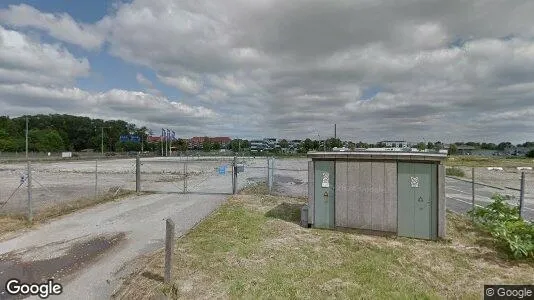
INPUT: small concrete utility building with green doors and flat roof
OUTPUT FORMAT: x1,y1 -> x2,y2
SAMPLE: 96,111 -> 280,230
308,151 -> 446,240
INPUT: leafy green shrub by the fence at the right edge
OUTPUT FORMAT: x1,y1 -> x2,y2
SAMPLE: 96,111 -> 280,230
469,194 -> 534,259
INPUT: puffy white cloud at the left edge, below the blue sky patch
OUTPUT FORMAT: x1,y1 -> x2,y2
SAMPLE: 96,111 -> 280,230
0,26 -> 90,85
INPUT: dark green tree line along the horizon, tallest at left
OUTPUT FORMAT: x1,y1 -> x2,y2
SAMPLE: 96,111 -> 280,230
0,114 -> 534,153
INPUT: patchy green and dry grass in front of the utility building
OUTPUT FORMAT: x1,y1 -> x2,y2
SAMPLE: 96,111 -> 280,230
117,186 -> 534,299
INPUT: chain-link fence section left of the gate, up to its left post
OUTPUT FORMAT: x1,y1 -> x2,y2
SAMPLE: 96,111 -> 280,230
0,159 -> 135,216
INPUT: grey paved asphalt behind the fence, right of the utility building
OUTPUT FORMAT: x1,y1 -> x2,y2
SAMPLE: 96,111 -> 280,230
445,178 -> 534,221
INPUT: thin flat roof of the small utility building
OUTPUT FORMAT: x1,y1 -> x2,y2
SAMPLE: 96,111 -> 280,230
308,151 -> 447,161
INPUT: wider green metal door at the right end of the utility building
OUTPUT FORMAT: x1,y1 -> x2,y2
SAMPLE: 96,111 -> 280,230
397,162 -> 437,239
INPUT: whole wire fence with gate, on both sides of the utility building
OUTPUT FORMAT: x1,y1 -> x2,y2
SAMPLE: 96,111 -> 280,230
0,156 -> 534,221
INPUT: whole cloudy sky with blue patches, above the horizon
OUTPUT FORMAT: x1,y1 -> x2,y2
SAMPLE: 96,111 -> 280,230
0,0 -> 534,143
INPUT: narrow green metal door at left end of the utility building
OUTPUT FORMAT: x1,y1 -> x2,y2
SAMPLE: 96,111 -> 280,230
313,161 -> 336,228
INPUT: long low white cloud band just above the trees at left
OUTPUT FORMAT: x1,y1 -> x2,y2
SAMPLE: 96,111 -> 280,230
0,84 -> 218,127
